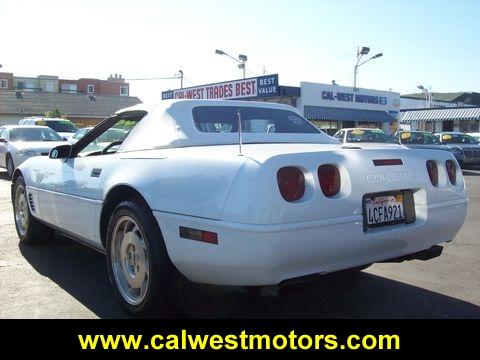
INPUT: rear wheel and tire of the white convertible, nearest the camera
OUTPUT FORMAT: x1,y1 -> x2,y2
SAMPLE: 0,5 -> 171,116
106,199 -> 181,317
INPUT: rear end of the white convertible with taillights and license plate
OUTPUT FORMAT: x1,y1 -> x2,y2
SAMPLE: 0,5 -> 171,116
159,144 -> 467,286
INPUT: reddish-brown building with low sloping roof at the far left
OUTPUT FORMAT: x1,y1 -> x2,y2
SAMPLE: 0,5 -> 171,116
0,72 -> 141,126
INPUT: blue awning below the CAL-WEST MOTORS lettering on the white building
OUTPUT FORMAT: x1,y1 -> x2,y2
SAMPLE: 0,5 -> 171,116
304,106 -> 396,123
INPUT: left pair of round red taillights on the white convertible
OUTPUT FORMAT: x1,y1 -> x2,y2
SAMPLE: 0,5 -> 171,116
277,165 -> 341,202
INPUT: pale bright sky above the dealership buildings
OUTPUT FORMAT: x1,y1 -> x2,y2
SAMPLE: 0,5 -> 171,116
0,0 -> 480,102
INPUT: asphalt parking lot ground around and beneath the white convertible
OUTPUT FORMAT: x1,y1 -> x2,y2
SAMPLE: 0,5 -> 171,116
0,168 -> 480,318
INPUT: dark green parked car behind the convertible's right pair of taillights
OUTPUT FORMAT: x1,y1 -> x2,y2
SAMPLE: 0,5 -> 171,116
394,131 -> 464,165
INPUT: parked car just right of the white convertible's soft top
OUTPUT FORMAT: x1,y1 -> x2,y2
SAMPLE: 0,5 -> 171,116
333,128 -> 404,149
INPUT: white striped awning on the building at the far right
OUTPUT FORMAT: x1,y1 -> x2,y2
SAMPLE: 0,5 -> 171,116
400,107 -> 480,122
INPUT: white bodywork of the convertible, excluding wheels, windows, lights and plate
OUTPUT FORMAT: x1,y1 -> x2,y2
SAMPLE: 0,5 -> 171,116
15,101 -> 467,286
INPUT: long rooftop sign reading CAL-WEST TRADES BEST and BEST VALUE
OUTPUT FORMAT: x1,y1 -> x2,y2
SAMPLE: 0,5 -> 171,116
162,74 -> 278,100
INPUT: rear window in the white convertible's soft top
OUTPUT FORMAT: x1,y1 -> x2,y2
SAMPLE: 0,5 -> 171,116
193,106 -> 320,134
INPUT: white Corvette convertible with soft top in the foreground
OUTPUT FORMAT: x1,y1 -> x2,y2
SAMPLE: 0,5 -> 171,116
12,100 -> 467,314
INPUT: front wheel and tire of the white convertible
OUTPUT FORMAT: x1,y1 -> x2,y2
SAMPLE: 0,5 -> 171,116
12,175 -> 55,245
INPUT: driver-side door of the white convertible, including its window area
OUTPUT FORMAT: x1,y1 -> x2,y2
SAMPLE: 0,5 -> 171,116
42,112 -> 145,247
